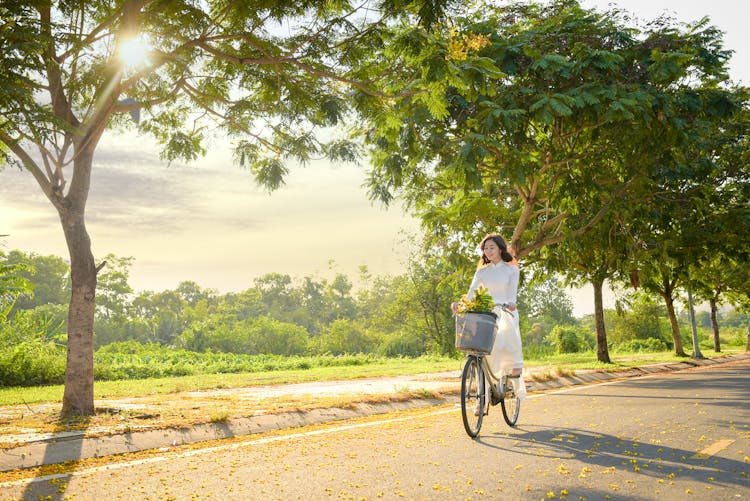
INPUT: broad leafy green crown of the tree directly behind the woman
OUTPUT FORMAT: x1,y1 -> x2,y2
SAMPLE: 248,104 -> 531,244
368,0 -> 741,356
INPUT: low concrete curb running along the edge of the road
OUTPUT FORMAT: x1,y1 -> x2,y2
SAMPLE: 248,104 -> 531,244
0,353 -> 750,472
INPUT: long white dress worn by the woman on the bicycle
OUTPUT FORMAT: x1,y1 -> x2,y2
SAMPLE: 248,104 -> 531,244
466,261 -> 526,399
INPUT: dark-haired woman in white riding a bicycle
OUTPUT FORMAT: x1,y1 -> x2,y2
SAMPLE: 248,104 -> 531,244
451,234 -> 526,399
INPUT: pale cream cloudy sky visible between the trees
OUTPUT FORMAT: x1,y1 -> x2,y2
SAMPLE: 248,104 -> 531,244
0,0 -> 750,316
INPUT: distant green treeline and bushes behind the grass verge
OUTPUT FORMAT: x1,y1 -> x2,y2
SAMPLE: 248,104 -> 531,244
0,250 -> 750,386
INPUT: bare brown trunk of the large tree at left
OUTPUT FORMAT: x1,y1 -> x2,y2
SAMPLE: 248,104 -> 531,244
58,151 -> 98,417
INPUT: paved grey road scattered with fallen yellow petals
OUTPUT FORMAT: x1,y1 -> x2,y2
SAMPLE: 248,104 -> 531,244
0,361 -> 750,501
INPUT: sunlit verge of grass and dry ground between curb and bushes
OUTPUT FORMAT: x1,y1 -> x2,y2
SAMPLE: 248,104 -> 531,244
0,349 -> 744,442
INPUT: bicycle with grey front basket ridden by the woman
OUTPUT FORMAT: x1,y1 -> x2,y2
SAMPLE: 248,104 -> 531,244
456,304 -> 521,438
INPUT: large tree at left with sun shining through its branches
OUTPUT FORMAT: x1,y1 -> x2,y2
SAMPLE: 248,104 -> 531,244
0,0 -> 446,415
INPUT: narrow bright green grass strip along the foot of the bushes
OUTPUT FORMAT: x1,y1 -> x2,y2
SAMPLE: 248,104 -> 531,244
0,348 -> 744,406
